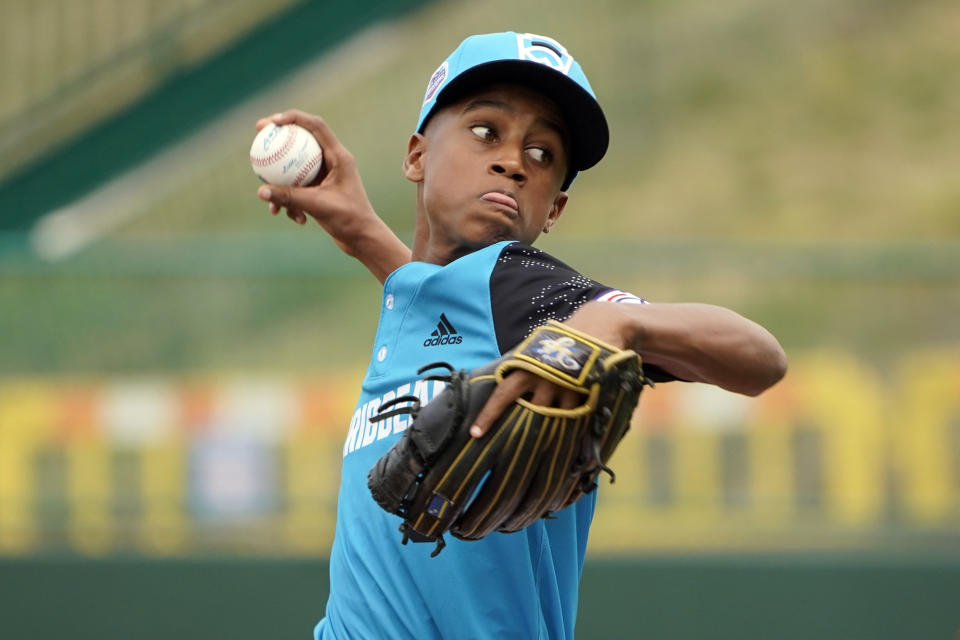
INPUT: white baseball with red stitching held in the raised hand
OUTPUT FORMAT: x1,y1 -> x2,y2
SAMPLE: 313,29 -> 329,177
250,123 -> 323,187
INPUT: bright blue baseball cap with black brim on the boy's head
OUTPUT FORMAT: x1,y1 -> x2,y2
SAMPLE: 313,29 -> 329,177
417,31 -> 610,190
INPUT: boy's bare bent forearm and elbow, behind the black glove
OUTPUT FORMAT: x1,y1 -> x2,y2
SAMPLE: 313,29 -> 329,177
568,303 -> 787,395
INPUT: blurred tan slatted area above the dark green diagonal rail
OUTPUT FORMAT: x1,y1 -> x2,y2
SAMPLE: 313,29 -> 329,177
0,0 -> 296,175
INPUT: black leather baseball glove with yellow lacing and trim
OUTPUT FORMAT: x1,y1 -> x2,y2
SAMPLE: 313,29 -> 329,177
368,322 -> 647,555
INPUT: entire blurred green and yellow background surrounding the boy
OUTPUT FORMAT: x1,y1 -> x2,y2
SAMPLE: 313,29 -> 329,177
0,0 -> 960,638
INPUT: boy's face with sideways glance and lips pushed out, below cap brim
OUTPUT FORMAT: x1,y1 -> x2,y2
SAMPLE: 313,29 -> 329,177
404,85 -> 569,258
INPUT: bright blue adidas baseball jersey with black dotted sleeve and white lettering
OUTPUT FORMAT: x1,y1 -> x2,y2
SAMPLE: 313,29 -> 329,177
315,242 -> 670,640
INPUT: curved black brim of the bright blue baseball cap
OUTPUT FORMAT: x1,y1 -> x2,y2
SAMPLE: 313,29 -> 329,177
420,60 -> 610,182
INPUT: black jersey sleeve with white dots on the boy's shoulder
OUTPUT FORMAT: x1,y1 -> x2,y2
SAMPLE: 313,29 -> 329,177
490,243 -> 679,382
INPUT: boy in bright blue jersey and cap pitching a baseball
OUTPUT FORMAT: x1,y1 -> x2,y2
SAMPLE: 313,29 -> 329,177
258,32 -> 786,640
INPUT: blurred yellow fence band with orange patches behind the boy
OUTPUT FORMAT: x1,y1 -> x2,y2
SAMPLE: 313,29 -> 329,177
0,344 -> 960,554
